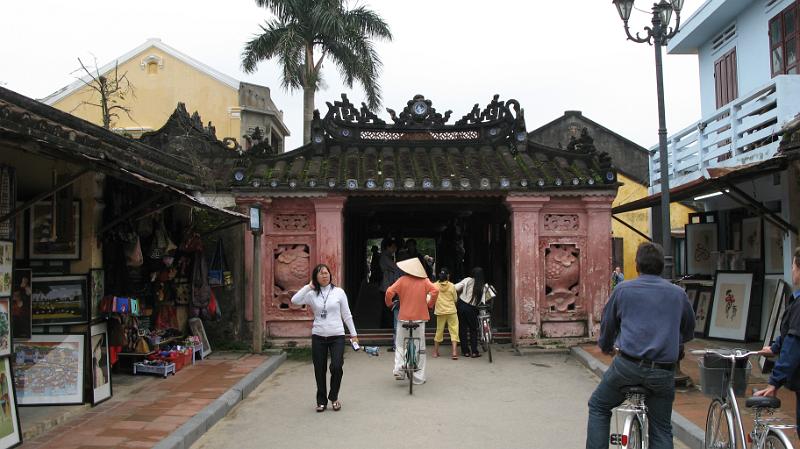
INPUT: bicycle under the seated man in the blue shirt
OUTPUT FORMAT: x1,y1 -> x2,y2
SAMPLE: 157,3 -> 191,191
609,385 -> 650,449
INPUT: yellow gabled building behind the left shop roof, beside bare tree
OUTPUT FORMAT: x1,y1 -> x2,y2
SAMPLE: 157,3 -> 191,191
41,39 -> 289,152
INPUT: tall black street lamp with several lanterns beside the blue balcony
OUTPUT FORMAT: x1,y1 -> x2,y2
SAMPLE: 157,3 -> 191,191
613,0 -> 683,279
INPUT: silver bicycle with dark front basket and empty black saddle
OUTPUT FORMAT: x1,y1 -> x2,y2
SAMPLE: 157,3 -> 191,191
692,349 -> 797,449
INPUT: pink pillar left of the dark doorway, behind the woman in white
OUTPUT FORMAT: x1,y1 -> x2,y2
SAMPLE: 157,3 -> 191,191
312,196 -> 347,285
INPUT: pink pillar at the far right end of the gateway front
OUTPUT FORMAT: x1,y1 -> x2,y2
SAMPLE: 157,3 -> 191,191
581,196 -> 616,338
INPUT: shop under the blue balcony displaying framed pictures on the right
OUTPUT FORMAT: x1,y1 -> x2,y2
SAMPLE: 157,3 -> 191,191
612,130 -> 800,344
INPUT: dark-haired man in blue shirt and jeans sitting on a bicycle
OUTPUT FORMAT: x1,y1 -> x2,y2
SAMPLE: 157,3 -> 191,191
586,242 -> 694,449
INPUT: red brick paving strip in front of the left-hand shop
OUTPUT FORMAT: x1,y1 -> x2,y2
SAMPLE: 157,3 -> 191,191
19,354 -> 267,449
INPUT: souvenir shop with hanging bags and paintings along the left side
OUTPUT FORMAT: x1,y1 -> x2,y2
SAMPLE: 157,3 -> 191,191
0,88 -> 246,448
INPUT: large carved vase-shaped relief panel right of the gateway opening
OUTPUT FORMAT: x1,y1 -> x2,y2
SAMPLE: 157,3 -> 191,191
544,244 -> 581,313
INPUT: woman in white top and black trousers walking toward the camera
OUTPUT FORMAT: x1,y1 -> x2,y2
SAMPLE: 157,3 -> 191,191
292,264 -> 358,412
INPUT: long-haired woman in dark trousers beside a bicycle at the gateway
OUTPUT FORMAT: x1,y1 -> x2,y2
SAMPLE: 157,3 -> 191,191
455,267 -> 488,357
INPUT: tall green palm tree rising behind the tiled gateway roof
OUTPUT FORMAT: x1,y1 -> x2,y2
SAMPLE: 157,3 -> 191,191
242,0 -> 392,144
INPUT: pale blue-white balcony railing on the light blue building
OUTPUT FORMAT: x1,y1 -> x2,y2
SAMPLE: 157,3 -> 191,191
649,75 -> 800,194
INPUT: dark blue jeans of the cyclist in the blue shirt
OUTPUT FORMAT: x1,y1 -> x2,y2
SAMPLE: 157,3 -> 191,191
586,357 -> 675,449
